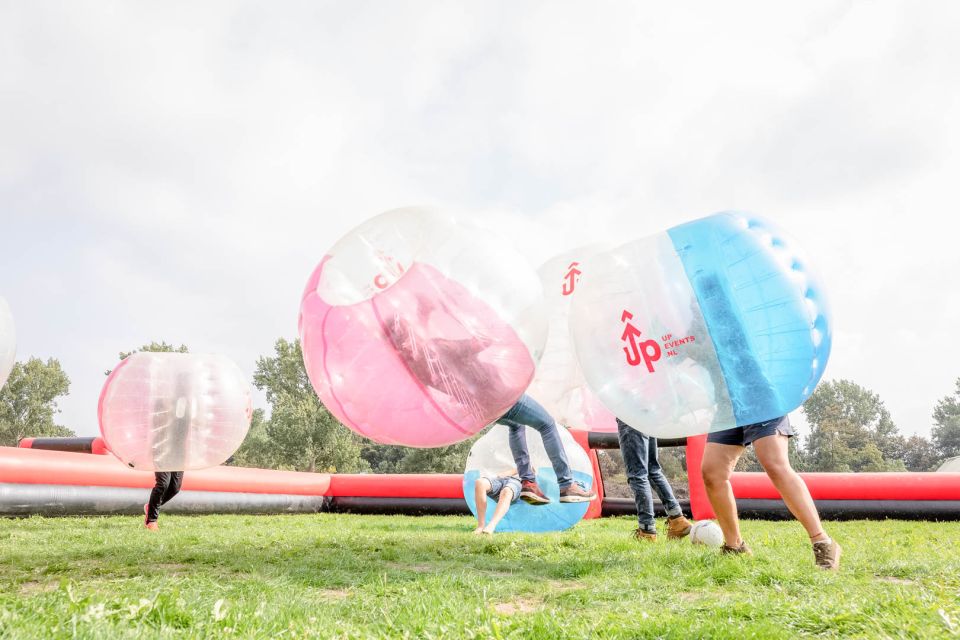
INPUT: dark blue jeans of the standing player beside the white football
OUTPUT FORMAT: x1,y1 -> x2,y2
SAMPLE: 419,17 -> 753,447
617,418 -> 683,532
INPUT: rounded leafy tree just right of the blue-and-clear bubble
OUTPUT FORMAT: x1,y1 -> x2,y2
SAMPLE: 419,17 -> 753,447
803,380 -> 905,471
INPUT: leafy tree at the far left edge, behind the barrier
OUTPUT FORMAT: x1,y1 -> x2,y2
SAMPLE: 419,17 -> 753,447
0,358 -> 76,447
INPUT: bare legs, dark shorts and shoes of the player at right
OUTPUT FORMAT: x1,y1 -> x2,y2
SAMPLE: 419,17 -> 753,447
701,416 -> 841,569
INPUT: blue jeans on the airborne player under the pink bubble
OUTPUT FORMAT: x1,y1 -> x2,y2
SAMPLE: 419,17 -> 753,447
497,394 -> 573,489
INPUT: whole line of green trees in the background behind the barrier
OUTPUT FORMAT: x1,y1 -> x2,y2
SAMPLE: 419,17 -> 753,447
0,338 -> 960,473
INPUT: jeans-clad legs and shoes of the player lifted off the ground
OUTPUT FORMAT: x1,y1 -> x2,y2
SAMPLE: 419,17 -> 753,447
497,394 -> 597,505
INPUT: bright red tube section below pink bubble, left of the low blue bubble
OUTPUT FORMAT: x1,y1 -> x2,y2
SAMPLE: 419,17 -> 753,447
327,473 -> 463,500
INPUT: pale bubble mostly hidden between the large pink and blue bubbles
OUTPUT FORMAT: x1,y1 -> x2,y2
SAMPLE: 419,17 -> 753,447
527,245 -> 617,433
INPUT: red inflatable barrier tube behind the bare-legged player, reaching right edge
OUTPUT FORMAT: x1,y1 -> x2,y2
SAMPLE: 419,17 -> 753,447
730,472 -> 960,500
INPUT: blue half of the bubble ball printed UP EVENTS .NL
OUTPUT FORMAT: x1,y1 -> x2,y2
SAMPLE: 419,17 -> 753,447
667,212 -> 831,425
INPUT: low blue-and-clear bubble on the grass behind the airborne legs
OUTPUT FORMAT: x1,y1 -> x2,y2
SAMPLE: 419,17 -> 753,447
463,424 -> 593,532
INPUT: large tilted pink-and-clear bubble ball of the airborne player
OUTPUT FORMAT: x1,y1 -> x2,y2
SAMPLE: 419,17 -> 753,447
300,208 -> 546,447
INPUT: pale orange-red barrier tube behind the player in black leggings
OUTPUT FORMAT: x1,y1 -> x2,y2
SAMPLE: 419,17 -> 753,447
0,447 -> 330,496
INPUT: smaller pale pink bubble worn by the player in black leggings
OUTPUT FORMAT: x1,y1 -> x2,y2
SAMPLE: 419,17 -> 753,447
99,352 -> 251,471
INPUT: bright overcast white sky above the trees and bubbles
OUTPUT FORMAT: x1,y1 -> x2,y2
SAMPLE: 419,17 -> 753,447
0,0 -> 960,435
